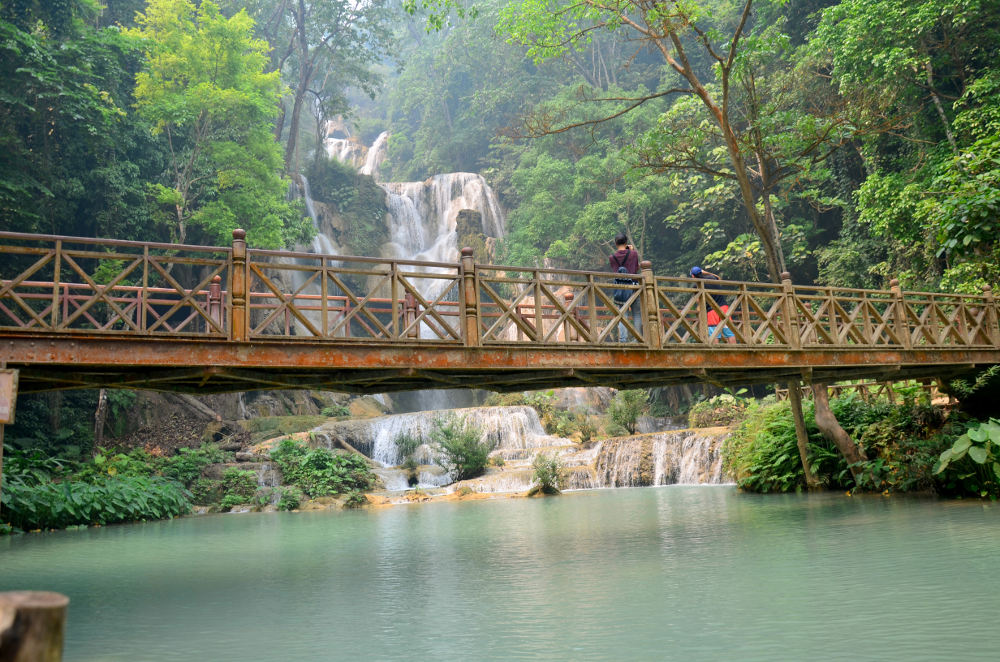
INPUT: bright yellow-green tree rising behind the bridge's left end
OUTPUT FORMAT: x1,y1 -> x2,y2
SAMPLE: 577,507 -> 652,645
129,0 -> 308,247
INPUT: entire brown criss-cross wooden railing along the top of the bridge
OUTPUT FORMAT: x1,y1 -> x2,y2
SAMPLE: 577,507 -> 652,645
0,231 -> 1000,350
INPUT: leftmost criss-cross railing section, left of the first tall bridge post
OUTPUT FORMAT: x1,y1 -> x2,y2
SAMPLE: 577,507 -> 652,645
0,232 -> 231,338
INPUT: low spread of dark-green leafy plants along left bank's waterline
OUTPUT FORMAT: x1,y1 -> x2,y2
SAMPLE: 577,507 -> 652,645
2,476 -> 191,530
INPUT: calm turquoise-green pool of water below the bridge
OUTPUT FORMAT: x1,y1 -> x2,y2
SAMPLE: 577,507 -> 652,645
0,487 -> 1000,662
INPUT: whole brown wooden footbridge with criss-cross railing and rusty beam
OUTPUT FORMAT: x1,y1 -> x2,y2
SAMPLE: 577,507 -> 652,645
0,230 -> 1000,393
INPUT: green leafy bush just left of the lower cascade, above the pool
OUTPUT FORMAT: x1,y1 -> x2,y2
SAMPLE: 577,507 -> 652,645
271,439 -> 375,498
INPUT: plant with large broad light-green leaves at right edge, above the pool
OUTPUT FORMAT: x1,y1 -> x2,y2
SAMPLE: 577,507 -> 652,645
934,418 -> 1000,499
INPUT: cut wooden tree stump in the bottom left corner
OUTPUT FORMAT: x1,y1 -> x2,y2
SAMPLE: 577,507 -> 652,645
0,591 -> 69,662
